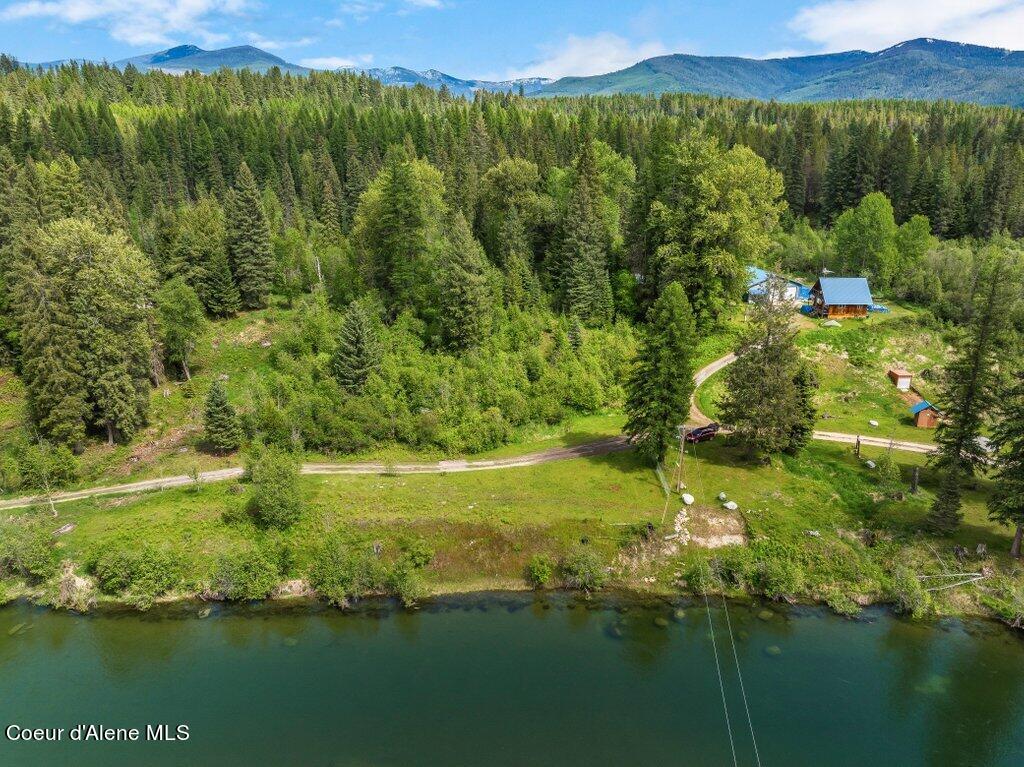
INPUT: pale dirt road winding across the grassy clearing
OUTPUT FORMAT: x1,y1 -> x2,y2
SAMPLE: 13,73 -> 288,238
0,353 -> 935,511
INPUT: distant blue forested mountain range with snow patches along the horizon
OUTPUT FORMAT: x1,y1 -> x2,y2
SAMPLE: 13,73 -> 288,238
22,38 -> 1024,106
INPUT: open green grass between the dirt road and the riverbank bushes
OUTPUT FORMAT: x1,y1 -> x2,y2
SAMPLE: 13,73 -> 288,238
14,441 -> 1010,606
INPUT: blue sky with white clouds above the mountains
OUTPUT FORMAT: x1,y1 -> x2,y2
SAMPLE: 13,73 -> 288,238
6,0 -> 1024,79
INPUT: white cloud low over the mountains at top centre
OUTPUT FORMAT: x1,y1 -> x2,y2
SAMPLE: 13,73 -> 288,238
503,32 -> 669,80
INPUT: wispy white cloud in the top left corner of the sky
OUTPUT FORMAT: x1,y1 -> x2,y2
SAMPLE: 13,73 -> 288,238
0,0 -> 249,45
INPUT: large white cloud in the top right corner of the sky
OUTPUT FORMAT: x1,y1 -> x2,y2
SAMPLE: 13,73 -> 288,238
788,0 -> 1024,51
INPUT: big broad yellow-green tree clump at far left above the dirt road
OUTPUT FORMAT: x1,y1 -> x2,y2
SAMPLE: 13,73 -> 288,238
15,218 -> 154,445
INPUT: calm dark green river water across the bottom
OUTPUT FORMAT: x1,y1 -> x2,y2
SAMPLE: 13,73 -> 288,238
0,596 -> 1024,767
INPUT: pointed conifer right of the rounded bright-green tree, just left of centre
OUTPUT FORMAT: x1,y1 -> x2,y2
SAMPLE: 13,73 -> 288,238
439,211 -> 492,350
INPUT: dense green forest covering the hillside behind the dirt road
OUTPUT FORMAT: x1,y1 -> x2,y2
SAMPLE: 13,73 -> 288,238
0,58 -> 1024,489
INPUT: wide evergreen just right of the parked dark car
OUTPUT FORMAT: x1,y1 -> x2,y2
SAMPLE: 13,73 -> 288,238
721,279 -> 815,458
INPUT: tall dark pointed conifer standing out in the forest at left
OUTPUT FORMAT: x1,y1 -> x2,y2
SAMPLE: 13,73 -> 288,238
227,162 -> 274,309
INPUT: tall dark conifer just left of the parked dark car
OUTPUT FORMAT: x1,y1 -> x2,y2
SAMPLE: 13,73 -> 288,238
626,283 -> 696,462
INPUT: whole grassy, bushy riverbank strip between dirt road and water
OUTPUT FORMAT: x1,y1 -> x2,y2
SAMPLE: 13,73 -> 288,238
0,445 -> 1024,628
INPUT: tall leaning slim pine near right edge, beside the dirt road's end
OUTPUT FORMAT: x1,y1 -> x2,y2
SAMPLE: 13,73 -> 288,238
927,246 -> 1015,534
